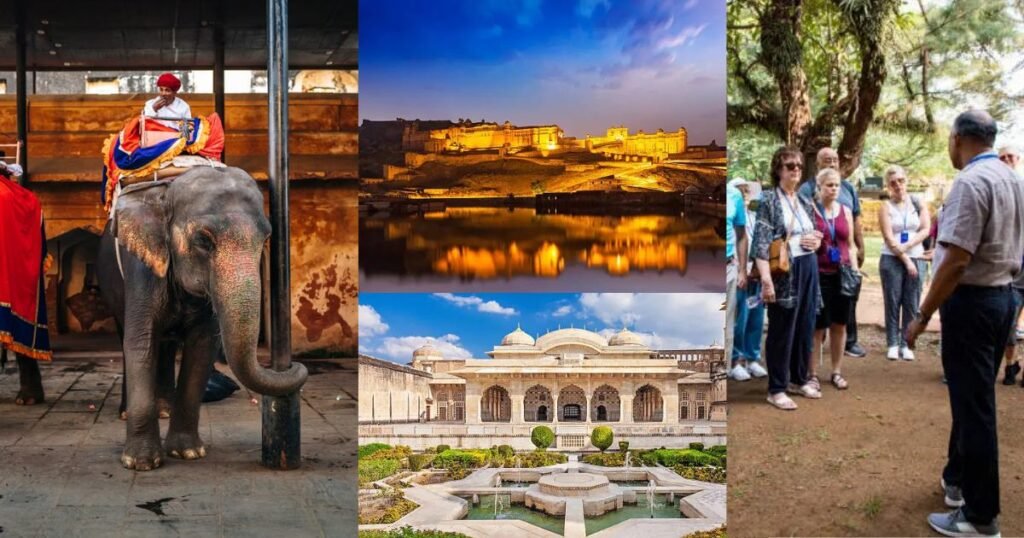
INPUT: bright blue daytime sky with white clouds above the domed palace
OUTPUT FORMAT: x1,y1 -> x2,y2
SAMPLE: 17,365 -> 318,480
359,293 -> 725,364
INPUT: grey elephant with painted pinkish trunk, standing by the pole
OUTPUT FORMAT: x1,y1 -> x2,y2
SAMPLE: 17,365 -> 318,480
96,167 -> 308,471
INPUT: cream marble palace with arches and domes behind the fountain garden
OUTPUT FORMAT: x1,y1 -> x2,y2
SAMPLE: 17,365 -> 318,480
359,328 -> 726,450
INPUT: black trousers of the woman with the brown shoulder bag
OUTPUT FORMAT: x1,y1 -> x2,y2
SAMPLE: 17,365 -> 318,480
765,254 -> 818,395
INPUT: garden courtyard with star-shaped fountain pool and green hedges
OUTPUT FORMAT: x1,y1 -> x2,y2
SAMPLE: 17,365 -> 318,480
358,426 -> 727,538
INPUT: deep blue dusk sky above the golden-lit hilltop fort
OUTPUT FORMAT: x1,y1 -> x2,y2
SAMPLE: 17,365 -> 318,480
359,0 -> 725,144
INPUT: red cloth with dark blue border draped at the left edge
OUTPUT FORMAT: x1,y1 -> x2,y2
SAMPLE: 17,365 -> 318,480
0,178 -> 51,361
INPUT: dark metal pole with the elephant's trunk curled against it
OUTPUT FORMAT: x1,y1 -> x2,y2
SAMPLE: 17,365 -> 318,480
262,0 -> 302,469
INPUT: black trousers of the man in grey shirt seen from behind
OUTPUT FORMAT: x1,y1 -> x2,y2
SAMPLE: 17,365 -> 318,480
941,286 -> 1014,525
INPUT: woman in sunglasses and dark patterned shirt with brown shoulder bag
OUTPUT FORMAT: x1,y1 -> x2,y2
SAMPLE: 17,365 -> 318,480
754,148 -> 822,411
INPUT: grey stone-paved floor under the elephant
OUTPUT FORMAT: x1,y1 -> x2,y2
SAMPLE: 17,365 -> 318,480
0,354 -> 356,537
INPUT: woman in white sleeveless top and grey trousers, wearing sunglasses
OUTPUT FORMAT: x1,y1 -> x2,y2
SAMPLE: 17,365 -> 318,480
879,165 -> 932,361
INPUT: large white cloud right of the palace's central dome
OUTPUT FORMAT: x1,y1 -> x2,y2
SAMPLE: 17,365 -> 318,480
580,293 -> 725,349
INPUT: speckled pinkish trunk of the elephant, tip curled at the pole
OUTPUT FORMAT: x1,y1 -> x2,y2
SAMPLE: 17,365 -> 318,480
210,255 -> 308,397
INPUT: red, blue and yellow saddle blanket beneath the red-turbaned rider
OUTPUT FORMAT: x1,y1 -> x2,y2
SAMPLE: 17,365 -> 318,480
101,114 -> 224,212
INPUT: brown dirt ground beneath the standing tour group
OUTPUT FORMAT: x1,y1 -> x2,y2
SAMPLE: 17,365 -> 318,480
729,323 -> 1024,537
